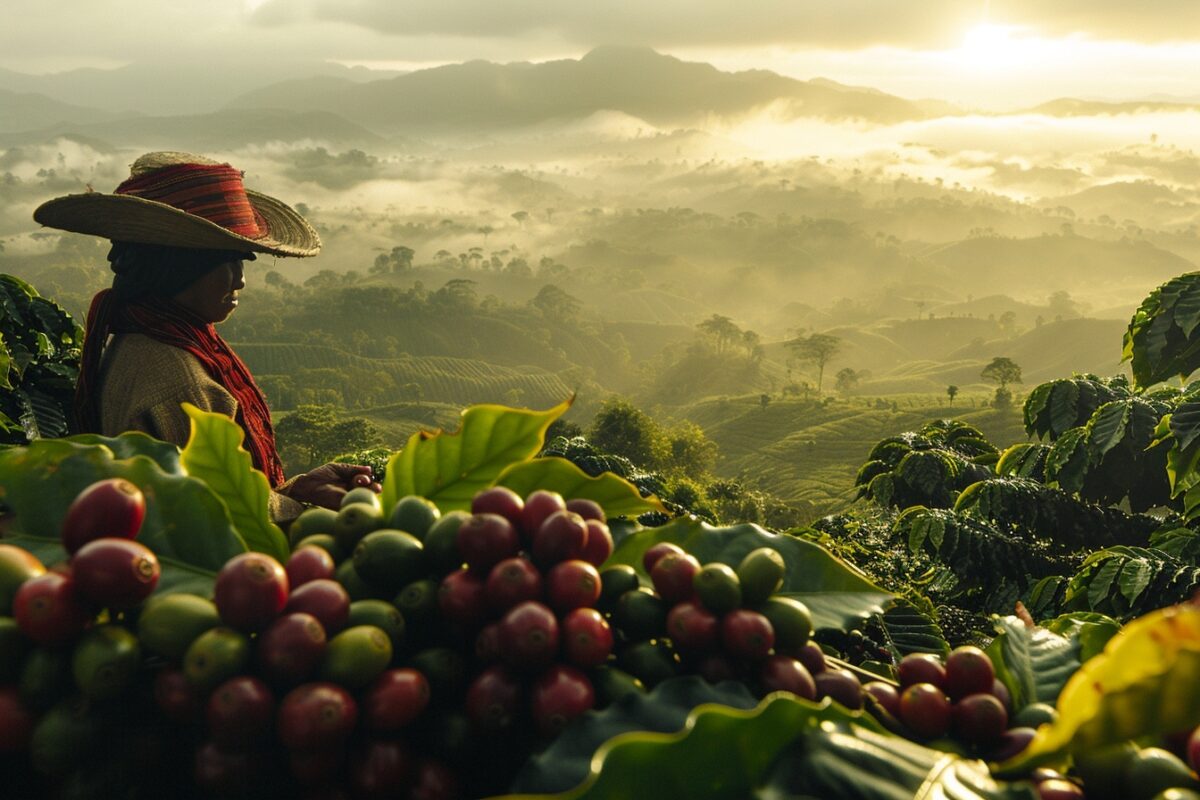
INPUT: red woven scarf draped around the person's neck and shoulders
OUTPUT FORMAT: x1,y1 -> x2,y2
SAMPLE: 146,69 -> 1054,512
76,289 -> 283,487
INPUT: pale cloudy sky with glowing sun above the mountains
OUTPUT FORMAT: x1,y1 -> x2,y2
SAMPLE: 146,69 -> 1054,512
0,0 -> 1200,109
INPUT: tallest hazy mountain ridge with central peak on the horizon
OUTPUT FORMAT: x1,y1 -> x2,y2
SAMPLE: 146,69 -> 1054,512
229,47 -> 928,132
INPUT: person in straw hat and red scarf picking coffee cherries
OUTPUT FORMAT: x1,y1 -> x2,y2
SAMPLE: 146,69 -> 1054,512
34,152 -> 379,523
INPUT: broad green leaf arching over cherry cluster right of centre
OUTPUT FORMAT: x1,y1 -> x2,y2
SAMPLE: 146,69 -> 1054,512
607,518 -> 894,627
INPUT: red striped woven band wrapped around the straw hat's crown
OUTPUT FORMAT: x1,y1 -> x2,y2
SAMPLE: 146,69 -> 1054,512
116,164 -> 268,239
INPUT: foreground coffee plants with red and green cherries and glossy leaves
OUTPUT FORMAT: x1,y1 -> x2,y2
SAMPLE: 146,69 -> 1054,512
0,276 -> 1200,800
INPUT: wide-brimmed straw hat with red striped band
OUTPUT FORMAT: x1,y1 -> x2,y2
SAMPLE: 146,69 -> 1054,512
34,152 -> 320,257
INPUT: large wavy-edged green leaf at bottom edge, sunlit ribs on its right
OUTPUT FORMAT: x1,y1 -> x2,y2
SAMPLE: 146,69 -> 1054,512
506,692 -> 1037,800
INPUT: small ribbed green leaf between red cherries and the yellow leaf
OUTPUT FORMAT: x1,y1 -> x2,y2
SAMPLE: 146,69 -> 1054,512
988,616 -> 1080,709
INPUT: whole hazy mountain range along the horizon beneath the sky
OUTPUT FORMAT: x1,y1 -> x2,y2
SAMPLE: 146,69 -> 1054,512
0,47 -> 1195,146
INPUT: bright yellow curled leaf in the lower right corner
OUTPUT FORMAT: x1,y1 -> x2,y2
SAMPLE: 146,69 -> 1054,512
1002,604 -> 1200,770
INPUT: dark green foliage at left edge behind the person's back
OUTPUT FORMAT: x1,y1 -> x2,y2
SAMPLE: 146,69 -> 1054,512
0,275 -> 83,444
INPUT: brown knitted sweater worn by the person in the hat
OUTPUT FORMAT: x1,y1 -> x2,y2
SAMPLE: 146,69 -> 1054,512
100,333 -> 304,523
